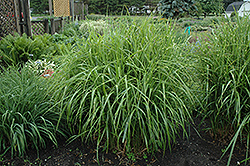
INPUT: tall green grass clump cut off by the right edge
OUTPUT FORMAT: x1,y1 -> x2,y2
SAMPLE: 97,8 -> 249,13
196,17 -> 250,165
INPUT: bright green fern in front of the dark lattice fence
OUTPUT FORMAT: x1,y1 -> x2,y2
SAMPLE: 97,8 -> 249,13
0,33 -> 57,66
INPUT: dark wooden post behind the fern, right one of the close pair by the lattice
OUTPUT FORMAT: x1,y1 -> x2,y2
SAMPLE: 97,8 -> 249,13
23,0 -> 32,36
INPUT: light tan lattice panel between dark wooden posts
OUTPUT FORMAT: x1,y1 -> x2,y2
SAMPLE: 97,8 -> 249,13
53,0 -> 70,17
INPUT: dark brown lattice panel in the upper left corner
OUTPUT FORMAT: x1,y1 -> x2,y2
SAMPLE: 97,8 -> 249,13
0,0 -> 17,37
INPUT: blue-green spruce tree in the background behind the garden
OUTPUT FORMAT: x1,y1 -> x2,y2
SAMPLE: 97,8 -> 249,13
160,0 -> 197,18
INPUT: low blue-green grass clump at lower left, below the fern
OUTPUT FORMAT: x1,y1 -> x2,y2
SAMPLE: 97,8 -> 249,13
0,68 -> 63,155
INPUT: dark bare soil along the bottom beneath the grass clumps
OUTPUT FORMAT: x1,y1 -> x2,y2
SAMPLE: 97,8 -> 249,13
0,118 -> 250,166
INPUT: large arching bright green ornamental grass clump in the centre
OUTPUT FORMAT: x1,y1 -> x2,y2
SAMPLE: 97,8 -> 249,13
53,16 -> 196,152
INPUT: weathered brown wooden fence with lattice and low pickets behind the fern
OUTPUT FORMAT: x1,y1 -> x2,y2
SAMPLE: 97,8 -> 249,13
0,0 -> 85,39
